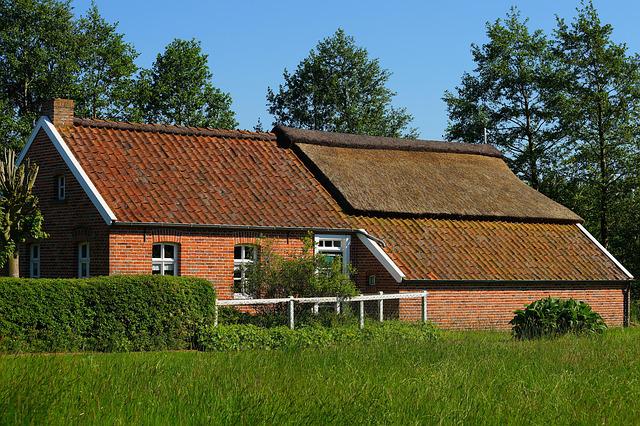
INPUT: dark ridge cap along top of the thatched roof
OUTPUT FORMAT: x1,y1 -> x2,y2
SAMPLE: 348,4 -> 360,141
272,125 -> 503,158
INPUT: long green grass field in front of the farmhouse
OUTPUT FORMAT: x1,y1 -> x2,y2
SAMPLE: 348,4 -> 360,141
0,328 -> 640,424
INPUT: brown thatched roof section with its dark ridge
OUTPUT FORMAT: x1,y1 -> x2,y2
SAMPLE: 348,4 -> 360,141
274,127 -> 581,222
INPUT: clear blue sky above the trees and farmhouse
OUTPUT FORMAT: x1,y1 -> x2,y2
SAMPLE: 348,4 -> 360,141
72,0 -> 640,139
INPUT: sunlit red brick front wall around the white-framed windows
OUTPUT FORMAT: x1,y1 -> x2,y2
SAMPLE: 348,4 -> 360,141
109,227 -> 304,299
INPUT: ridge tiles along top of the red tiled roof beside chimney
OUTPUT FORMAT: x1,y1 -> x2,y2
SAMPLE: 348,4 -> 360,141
73,117 -> 276,141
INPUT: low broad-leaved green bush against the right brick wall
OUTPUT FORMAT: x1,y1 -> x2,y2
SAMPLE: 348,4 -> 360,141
509,297 -> 607,339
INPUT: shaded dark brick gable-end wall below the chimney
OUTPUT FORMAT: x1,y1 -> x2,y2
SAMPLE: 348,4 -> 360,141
20,131 -> 109,277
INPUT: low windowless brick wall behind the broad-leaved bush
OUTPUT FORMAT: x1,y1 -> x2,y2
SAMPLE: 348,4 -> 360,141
400,283 -> 627,329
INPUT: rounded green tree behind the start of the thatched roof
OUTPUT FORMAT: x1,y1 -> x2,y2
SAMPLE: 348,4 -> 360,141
267,29 -> 417,137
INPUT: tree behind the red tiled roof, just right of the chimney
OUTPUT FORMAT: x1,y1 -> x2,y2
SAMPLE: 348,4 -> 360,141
132,39 -> 238,128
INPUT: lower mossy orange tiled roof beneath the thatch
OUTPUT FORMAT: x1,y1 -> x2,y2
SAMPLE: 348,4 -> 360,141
351,217 -> 627,281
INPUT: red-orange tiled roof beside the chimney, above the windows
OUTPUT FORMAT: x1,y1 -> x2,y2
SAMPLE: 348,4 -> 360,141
60,119 -> 348,228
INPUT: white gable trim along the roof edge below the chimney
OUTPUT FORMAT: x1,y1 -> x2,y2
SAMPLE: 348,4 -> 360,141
17,116 -> 116,225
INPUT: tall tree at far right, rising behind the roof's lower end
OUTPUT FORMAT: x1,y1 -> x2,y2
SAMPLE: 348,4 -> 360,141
555,2 -> 640,246
